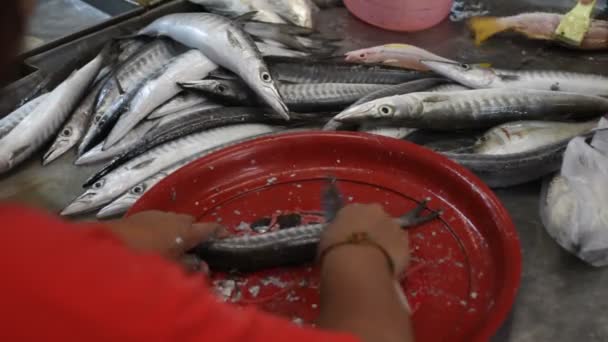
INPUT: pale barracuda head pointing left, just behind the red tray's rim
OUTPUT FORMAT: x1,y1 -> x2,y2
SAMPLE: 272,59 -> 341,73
334,95 -> 422,122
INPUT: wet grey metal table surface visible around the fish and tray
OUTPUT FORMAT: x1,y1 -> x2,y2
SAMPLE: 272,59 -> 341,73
0,0 -> 608,342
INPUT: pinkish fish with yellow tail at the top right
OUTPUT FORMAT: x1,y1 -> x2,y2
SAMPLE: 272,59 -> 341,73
469,12 -> 608,50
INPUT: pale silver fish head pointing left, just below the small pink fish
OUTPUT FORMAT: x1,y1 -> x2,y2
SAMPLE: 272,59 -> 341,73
420,60 -> 497,88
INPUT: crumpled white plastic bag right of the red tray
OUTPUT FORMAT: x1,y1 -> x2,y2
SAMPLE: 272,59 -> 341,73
541,119 -> 608,266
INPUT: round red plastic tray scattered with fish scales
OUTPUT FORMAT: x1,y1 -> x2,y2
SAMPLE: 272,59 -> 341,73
129,132 -> 521,341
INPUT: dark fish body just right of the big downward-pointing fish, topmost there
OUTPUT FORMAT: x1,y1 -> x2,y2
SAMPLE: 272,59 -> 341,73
264,57 -> 437,84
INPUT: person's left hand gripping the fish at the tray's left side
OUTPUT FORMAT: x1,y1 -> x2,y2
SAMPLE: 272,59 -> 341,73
106,211 -> 227,270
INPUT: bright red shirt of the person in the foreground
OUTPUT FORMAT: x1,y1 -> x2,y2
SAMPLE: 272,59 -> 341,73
0,206 -> 356,342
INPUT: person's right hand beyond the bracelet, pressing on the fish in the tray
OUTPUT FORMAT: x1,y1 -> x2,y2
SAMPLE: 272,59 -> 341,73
319,204 -> 410,276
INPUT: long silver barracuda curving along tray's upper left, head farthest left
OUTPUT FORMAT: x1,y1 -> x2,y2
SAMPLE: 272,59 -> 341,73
61,124 -> 274,215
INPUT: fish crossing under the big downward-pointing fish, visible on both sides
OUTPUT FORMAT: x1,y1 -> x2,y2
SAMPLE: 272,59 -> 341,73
180,80 -> 388,112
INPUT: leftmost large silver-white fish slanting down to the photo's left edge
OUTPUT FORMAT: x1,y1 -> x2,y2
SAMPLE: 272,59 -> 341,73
0,45 -> 110,173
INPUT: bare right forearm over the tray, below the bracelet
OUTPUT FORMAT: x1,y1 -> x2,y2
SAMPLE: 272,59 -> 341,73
317,246 -> 413,342
